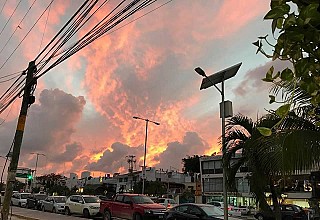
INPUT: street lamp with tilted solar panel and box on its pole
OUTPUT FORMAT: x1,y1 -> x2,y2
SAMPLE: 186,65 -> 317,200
194,63 -> 242,220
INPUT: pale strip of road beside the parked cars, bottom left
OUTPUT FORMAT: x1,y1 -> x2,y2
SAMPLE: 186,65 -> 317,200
8,206 -> 102,220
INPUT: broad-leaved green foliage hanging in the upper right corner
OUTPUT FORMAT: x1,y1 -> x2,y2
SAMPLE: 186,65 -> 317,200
253,0 -> 320,136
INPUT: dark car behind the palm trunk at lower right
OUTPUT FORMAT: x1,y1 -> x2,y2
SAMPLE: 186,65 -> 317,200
254,204 -> 308,220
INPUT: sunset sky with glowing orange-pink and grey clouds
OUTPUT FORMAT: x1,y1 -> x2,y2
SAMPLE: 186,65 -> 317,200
0,0 -> 290,176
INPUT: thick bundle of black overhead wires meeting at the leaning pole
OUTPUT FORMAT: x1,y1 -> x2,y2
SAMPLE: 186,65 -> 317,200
0,0 -> 173,114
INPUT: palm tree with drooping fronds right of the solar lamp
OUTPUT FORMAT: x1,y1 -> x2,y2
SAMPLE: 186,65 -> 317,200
225,110 -> 320,219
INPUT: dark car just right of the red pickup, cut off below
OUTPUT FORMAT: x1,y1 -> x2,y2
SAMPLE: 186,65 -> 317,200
166,203 -> 223,220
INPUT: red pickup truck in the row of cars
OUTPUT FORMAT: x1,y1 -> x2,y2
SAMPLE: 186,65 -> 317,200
100,193 -> 166,220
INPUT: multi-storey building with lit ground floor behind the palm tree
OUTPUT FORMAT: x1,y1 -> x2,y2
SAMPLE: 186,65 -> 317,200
200,153 -> 320,208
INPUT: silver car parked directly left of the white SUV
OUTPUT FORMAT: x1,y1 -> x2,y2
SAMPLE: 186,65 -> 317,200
41,196 -> 67,213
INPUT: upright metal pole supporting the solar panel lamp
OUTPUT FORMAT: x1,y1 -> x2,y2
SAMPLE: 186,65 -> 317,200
221,80 -> 228,220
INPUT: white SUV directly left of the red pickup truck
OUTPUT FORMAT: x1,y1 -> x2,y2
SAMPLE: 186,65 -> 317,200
64,195 -> 100,218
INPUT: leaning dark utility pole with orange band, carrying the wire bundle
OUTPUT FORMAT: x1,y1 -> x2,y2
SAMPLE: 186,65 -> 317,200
1,61 -> 36,220
